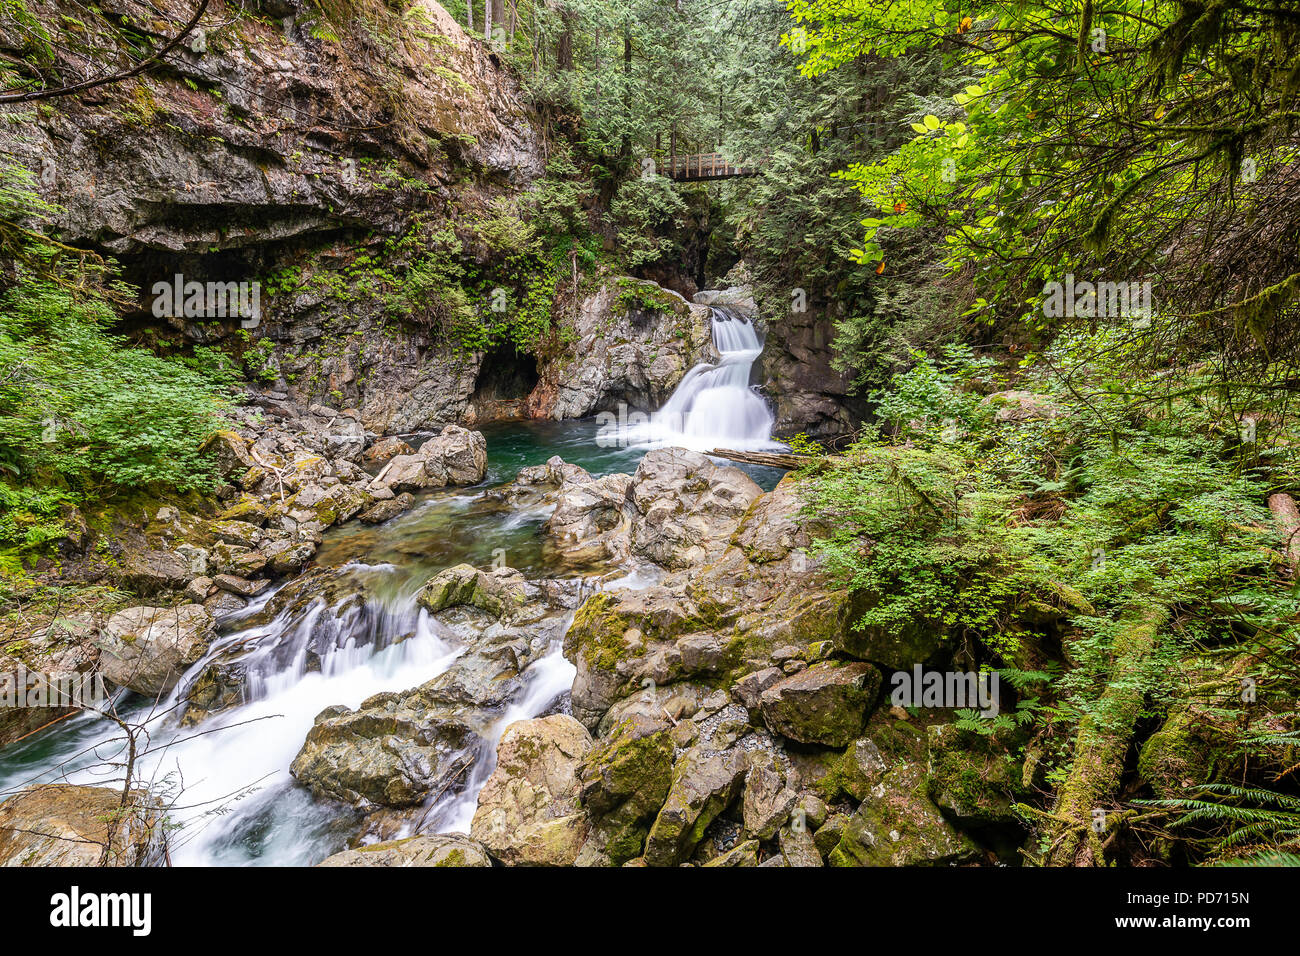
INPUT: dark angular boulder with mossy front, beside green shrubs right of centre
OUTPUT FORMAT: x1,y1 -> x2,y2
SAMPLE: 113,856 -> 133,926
759,661 -> 880,747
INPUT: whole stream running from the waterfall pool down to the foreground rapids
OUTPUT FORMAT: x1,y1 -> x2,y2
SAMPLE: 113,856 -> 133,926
0,335 -> 781,865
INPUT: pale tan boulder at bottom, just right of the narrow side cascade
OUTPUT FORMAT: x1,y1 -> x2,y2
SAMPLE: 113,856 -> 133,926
469,714 -> 592,866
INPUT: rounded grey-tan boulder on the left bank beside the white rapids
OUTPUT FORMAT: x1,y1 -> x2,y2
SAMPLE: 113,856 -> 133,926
98,604 -> 216,697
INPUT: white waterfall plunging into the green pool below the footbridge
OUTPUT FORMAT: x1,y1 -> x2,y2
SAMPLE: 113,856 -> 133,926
631,307 -> 783,451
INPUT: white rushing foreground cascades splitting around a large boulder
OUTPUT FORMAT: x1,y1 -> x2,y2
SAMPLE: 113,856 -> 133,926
0,563 -> 575,865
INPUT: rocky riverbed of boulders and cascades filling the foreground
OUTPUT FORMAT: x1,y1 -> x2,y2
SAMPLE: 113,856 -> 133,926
0,418 -> 1023,866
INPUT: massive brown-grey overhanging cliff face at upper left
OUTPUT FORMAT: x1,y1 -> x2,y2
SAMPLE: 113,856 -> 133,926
0,0 -> 545,434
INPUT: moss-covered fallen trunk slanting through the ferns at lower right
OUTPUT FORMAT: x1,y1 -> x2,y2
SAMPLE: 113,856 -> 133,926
1047,606 -> 1169,866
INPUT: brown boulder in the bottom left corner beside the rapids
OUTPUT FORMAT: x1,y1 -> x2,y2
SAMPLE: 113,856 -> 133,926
0,783 -> 166,866
